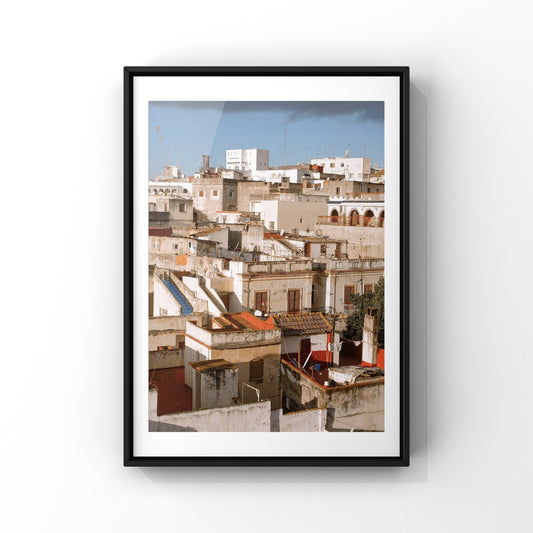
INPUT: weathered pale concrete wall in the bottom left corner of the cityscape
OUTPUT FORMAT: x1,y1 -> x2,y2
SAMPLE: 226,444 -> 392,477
149,389 -> 270,432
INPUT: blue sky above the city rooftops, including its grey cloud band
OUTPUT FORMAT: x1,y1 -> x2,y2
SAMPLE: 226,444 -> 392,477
149,101 -> 384,178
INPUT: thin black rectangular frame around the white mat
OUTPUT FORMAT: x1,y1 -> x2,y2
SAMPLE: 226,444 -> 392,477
123,66 -> 409,467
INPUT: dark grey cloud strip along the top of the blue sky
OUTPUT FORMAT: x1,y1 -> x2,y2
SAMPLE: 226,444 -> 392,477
151,101 -> 384,123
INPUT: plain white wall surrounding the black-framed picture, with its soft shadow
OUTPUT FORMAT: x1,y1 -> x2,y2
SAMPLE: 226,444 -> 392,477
0,0 -> 533,533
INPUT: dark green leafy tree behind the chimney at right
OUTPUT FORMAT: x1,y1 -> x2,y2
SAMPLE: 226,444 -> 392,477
343,278 -> 385,348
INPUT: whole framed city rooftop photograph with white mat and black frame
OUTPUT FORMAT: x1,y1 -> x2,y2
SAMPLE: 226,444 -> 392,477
124,67 -> 409,466
